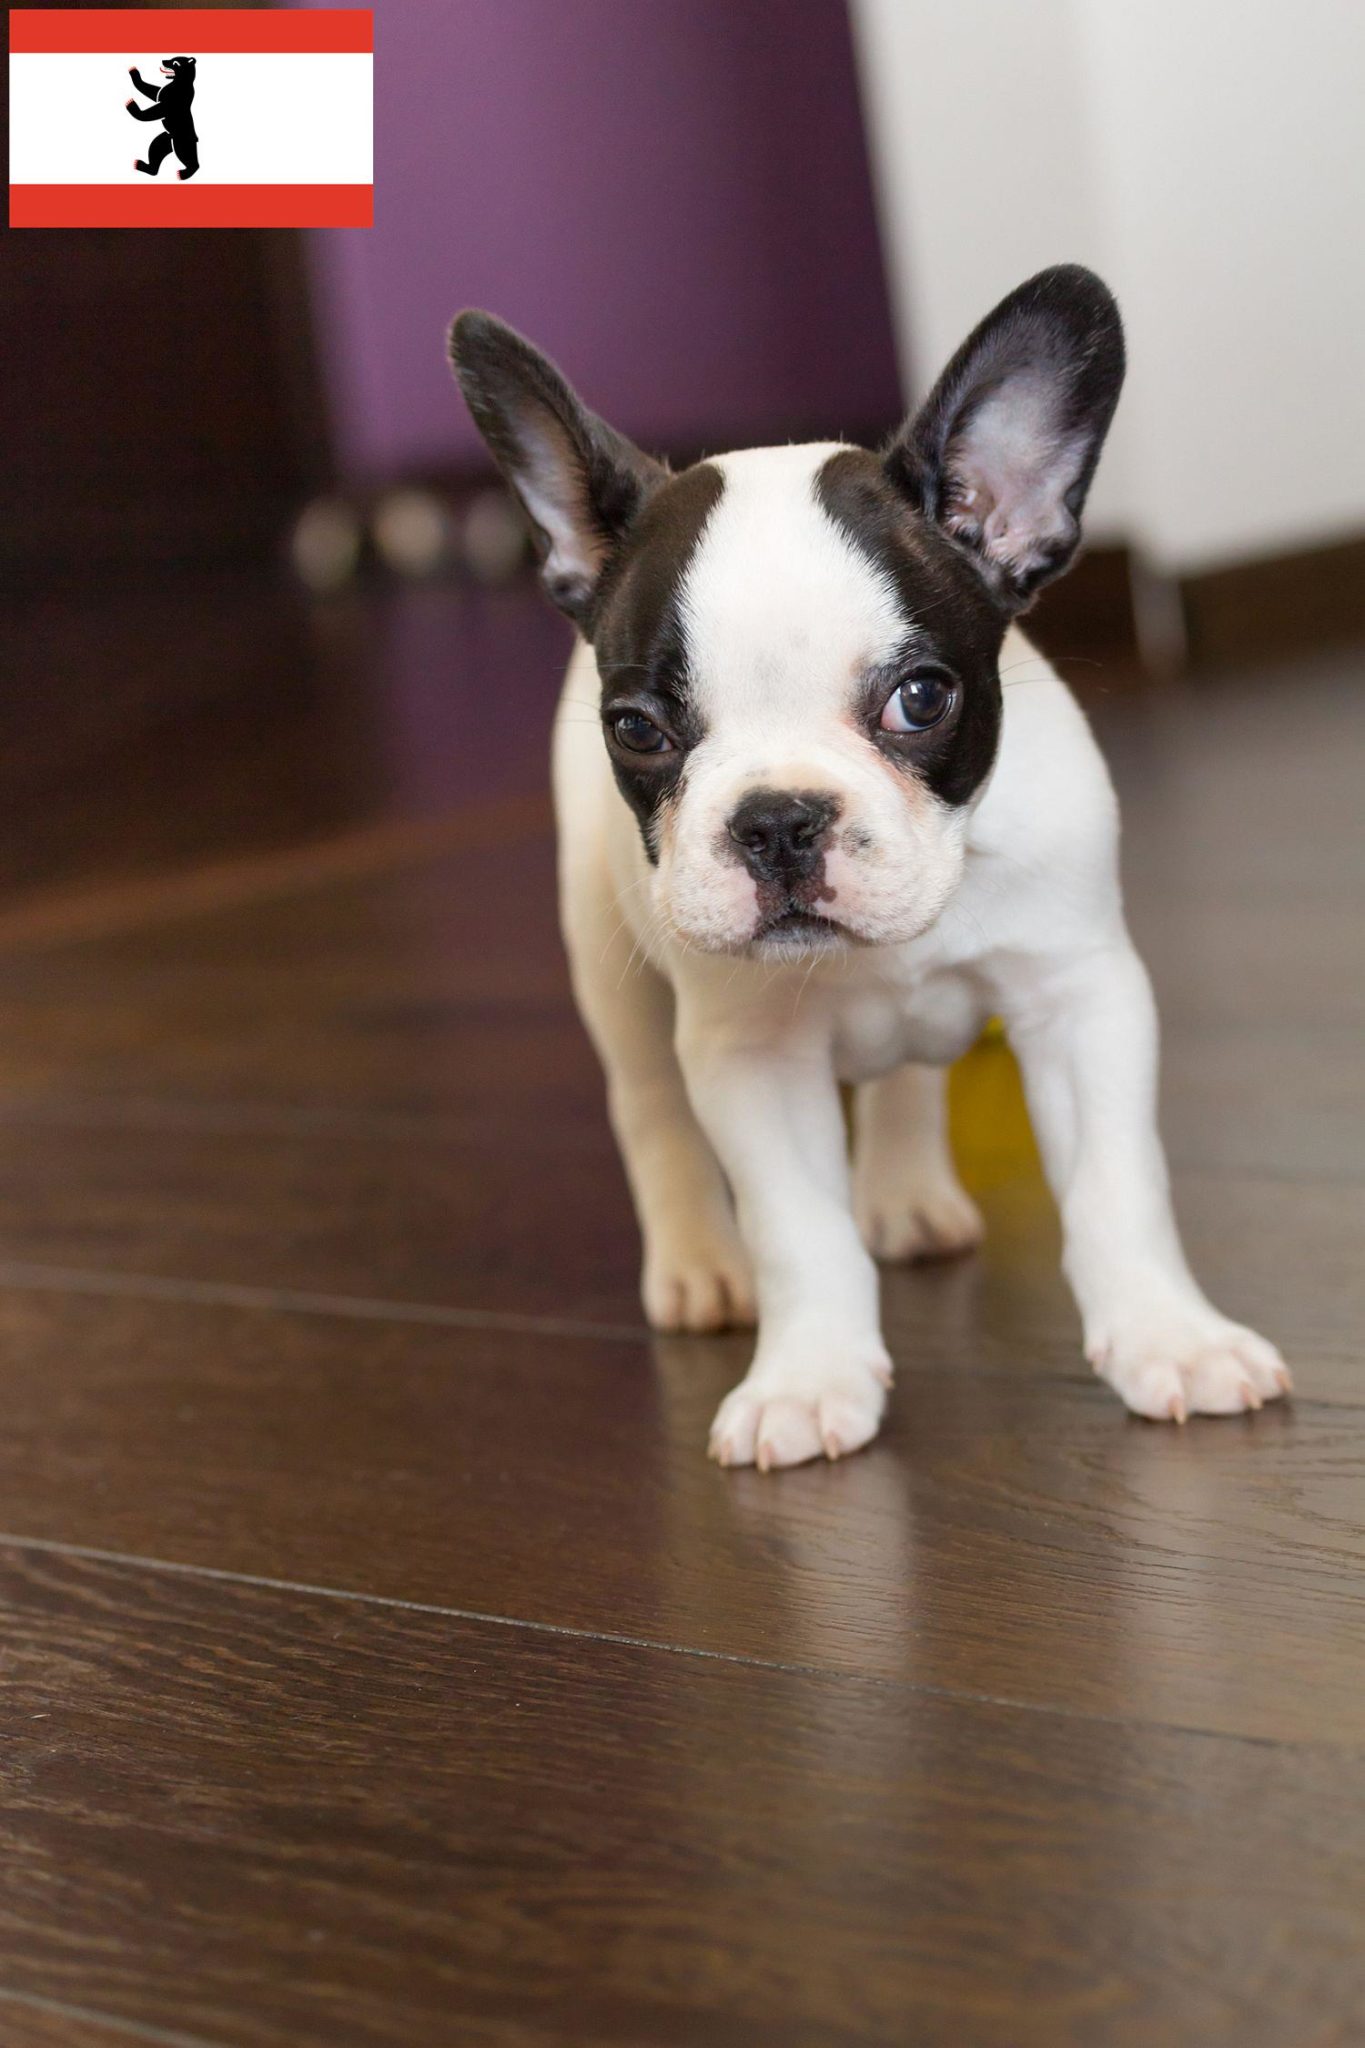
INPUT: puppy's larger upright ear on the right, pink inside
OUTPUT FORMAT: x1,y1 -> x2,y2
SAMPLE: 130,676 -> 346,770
884,264 -> 1124,610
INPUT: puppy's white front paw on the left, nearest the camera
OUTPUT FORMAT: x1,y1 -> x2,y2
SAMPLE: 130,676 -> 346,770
708,1346 -> 890,1473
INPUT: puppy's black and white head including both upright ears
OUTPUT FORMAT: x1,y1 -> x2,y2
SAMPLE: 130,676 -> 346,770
450,266 -> 1124,956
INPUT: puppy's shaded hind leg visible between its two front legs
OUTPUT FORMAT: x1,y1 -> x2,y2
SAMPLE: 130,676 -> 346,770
853,1067 -> 984,1260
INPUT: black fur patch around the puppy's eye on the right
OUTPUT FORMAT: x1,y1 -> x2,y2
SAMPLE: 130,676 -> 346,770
814,449 -> 1009,805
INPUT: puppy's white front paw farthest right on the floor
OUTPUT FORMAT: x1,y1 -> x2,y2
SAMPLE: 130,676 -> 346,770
1087,1311 -> 1293,1421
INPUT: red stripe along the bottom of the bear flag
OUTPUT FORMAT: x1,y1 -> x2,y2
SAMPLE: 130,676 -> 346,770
10,184 -> 375,227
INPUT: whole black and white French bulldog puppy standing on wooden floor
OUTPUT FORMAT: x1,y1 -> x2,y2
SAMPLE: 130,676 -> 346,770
450,266 -> 1289,1468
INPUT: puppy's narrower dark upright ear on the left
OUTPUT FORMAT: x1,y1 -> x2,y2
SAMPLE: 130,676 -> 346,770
450,313 -> 667,627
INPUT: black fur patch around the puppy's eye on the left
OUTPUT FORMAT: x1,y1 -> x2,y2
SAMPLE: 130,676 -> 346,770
583,463 -> 724,862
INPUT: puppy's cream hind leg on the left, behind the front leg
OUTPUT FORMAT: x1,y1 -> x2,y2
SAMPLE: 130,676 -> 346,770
563,860 -> 755,1331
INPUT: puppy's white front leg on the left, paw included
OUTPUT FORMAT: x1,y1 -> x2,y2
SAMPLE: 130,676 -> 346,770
677,1004 -> 890,1470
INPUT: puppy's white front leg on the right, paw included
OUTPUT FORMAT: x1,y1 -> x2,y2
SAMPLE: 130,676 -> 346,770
1003,940 -> 1291,1421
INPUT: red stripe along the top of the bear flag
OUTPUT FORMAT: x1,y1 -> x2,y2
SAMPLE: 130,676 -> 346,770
10,6 -> 375,57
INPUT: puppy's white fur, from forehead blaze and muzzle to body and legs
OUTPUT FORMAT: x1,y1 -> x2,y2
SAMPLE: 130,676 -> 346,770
555,446 -> 1289,1466
